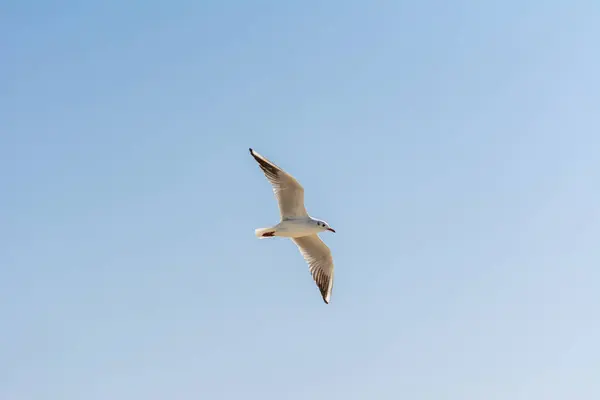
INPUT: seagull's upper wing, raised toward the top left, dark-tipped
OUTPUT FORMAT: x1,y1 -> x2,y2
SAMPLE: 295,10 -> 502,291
250,149 -> 308,219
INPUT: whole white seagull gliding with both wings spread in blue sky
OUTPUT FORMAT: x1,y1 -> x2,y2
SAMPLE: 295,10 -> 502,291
250,149 -> 335,304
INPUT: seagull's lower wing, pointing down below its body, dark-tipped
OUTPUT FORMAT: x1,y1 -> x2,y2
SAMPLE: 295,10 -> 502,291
292,234 -> 333,304
